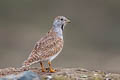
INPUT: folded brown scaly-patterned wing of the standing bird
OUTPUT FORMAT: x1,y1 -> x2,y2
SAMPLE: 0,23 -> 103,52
23,33 -> 63,63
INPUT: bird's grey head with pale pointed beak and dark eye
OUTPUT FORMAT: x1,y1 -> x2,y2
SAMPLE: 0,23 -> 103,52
53,16 -> 70,30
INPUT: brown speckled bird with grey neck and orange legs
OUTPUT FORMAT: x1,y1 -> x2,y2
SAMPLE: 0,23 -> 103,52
22,16 -> 70,72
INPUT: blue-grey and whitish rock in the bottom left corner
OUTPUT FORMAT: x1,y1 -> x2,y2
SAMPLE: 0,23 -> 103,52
0,71 -> 40,80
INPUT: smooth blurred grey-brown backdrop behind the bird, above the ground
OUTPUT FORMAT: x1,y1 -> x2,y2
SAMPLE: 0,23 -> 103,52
0,0 -> 120,72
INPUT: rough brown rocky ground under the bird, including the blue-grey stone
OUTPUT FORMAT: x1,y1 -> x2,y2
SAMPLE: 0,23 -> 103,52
0,67 -> 120,80
